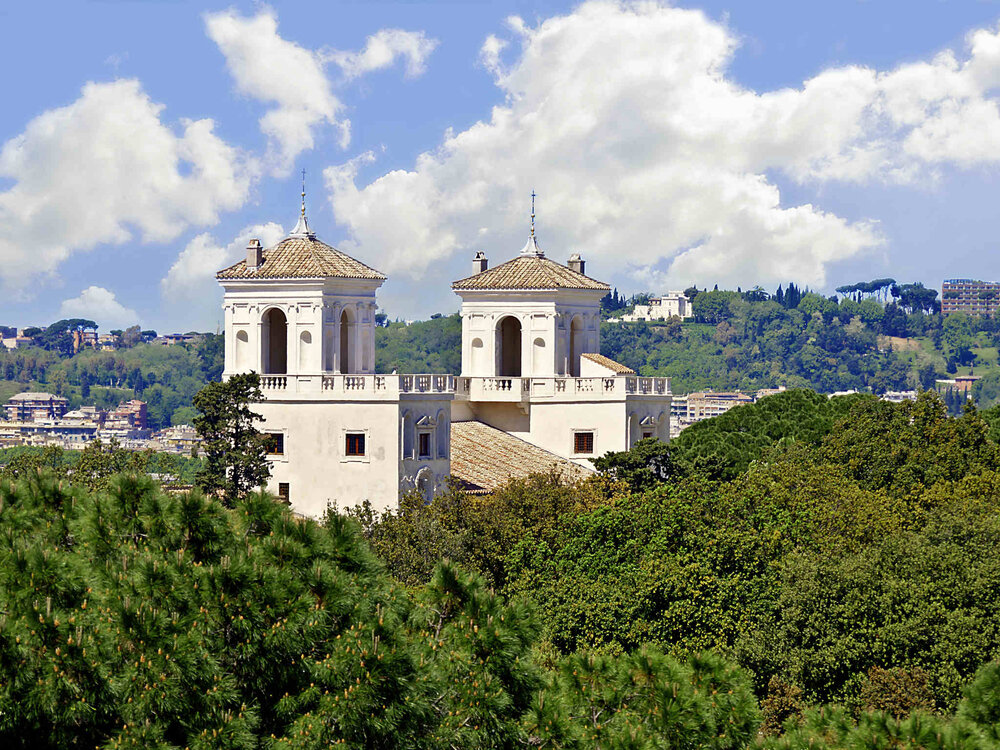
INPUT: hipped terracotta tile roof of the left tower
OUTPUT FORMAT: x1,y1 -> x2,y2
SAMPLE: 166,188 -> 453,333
215,236 -> 386,281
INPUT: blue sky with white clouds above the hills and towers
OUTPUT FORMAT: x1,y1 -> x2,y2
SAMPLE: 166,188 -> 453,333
0,0 -> 1000,331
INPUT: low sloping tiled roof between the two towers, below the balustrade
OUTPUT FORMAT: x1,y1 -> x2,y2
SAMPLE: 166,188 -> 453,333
451,422 -> 594,493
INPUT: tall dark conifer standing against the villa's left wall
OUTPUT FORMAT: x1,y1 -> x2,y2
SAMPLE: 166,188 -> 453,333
194,372 -> 271,506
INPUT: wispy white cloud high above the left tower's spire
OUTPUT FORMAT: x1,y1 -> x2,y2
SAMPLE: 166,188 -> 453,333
205,8 -> 437,175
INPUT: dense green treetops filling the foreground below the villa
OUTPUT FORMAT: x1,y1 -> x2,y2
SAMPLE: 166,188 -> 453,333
0,391 -> 1000,750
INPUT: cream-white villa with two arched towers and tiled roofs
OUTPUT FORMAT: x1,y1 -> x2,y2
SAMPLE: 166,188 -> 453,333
217,197 -> 670,516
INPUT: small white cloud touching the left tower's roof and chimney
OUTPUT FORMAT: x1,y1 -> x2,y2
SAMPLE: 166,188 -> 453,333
160,222 -> 285,308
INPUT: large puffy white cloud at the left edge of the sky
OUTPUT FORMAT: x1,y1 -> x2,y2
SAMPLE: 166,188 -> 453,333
0,80 -> 249,297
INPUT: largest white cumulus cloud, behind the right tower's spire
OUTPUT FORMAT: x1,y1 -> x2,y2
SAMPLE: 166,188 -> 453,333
325,0 -> 1000,287
